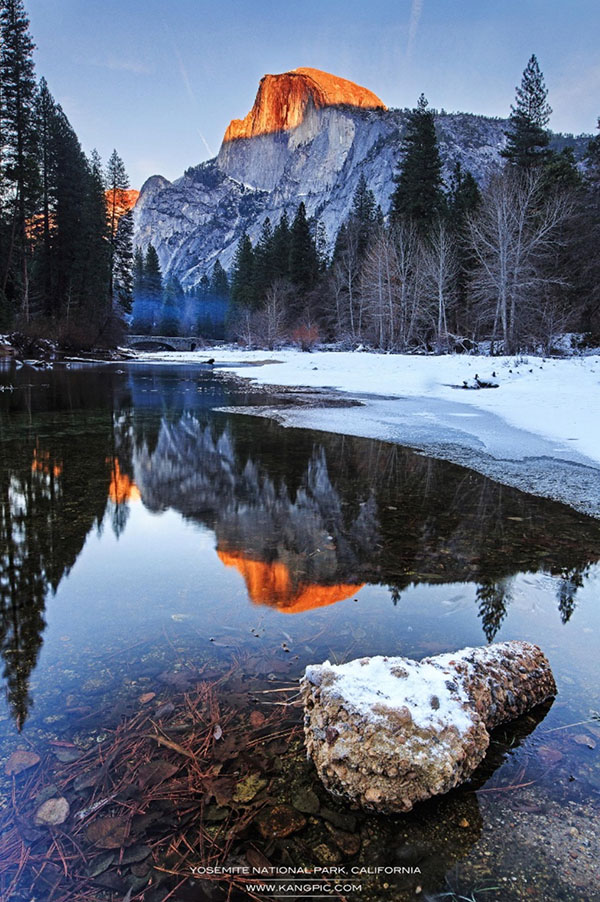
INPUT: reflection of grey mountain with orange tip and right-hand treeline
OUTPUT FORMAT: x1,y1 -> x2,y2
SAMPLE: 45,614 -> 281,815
133,414 -> 600,640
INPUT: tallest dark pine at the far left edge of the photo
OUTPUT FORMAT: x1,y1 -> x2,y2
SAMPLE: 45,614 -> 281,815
0,0 -> 39,321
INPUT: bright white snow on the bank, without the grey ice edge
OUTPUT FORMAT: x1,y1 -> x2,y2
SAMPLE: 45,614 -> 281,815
135,348 -> 600,463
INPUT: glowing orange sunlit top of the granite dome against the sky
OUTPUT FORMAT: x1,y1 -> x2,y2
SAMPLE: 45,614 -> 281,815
224,68 -> 386,141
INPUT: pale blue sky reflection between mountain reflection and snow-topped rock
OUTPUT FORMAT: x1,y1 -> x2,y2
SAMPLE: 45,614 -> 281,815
29,501 -> 600,740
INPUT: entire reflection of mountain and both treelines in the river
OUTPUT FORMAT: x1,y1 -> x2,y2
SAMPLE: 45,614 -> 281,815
0,358 -> 600,726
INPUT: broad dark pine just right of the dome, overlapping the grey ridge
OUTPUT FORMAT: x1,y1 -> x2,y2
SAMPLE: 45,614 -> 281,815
390,94 -> 445,234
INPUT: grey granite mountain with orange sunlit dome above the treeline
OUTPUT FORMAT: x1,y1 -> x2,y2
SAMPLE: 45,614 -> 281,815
134,69 -> 506,286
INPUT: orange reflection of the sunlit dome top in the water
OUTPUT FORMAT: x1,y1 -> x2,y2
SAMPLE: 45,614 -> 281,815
217,549 -> 364,614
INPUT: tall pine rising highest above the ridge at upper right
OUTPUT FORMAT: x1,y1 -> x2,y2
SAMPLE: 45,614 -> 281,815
502,54 -> 552,169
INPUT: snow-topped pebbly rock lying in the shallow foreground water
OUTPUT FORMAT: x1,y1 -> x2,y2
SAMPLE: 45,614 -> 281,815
301,641 -> 556,812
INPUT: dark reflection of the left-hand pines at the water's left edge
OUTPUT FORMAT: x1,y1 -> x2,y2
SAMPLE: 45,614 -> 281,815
0,372 -> 132,729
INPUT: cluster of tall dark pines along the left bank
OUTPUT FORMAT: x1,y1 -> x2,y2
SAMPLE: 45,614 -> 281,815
0,0 -> 125,344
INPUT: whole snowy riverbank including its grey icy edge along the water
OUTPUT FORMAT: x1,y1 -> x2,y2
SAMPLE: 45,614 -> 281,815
135,348 -> 600,516
